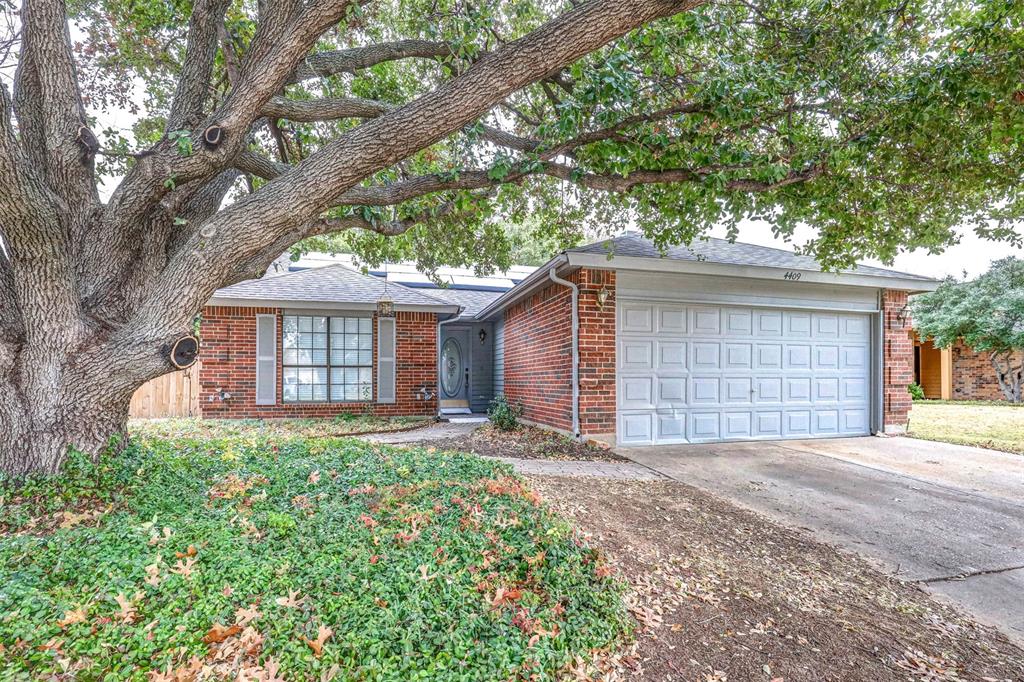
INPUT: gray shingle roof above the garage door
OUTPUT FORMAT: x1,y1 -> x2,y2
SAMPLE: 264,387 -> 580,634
569,232 -> 934,282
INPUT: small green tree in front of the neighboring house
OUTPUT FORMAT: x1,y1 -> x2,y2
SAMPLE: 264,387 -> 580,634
912,258 -> 1024,402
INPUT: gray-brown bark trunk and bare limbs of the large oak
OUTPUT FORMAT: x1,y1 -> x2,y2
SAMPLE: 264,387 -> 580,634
0,0 -> 699,476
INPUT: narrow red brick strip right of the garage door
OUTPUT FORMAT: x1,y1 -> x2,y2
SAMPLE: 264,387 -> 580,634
882,290 -> 913,432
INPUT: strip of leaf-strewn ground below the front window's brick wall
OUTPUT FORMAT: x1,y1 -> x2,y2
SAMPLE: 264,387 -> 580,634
128,415 -> 433,438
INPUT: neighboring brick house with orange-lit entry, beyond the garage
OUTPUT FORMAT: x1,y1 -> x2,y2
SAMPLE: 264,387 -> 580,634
913,335 -> 1024,400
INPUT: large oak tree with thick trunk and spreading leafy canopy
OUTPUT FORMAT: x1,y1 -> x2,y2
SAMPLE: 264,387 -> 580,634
0,0 -> 1024,475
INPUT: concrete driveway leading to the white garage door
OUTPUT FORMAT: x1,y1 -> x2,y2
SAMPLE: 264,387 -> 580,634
616,437 -> 1024,642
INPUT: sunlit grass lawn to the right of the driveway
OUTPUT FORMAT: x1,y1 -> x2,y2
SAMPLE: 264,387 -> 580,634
909,400 -> 1024,455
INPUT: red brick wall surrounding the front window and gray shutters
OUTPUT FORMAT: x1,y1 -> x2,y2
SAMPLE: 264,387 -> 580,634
199,306 -> 437,419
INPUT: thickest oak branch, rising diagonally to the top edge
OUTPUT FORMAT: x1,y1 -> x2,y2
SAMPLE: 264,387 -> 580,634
133,0 -> 698,329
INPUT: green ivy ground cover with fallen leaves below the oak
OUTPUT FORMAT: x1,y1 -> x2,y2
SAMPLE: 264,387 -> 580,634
0,437 -> 629,682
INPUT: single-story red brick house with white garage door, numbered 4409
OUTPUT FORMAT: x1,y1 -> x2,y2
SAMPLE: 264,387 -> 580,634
200,232 -> 938,444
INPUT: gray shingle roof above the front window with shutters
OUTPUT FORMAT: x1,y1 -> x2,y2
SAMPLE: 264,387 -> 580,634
214,265 -> 452,307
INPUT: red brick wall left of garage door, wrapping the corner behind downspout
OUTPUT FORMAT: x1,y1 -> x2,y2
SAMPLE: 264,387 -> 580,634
505,268 -> 615,434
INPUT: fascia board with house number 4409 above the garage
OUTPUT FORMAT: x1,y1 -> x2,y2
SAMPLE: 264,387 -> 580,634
565,251 -> 940,290
